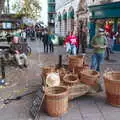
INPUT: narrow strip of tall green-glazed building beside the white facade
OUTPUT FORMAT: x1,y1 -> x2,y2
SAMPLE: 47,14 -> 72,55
48,0 -> 56,32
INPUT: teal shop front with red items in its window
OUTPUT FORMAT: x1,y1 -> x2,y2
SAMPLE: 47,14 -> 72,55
89,2 -> 120,51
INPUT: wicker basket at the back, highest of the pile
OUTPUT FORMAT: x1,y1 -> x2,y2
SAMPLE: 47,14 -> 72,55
68,56 -> 84,70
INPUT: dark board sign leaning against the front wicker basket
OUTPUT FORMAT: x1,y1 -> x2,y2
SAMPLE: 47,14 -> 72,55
30,86 -> 45,120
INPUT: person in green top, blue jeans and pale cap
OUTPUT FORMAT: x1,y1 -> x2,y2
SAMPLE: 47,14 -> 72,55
91,28 -> 107,71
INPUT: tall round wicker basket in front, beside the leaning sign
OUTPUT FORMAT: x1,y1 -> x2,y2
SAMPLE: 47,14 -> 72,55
45,86 -> 68,117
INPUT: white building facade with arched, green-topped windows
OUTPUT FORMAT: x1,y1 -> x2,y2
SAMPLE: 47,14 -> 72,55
55,0 -> 79,36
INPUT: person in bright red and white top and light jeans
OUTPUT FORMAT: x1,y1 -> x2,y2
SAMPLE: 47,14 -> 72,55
67,31 -> 79,55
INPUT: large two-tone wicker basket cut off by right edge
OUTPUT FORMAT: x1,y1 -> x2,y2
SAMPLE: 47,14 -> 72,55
104,71 -> 120,106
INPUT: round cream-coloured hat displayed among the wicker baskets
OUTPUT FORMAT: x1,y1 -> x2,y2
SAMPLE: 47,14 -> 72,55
46,73 -> 60,87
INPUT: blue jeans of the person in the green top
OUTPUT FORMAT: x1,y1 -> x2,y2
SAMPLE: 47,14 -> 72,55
91,53 -> 104,72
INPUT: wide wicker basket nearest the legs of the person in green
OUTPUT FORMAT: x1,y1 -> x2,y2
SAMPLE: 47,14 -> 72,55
80,69 -> 100,86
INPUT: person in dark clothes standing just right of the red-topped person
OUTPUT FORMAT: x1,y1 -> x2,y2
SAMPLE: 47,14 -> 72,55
81,27 -> 87,53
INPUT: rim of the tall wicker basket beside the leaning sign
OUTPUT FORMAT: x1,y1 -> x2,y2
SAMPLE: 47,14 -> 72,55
45,86 -> 68,97
